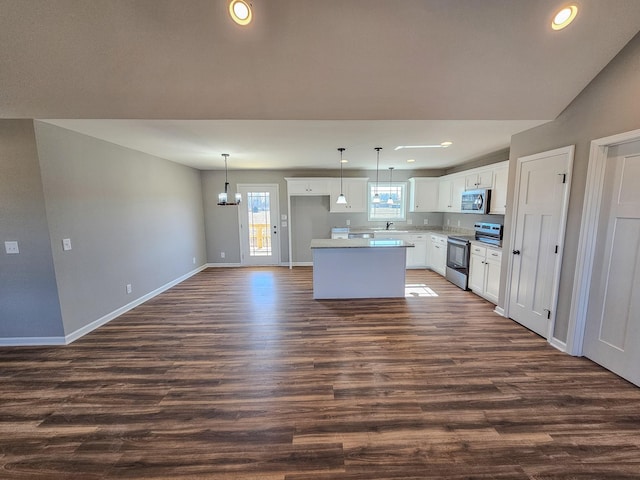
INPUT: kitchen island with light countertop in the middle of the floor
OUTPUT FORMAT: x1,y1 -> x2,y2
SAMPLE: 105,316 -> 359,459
311,238 -> 413,299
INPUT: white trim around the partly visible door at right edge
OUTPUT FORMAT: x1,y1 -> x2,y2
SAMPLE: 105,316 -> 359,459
566,130 -> 640,356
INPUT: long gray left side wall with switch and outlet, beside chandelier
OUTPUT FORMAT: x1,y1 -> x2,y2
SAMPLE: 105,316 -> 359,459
35,122 -> 205,335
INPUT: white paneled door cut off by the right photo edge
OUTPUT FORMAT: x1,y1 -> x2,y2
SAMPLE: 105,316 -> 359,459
583,141 -> 640,385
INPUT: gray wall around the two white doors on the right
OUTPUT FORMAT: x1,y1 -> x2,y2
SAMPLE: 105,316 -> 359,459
500,34 -> 640,341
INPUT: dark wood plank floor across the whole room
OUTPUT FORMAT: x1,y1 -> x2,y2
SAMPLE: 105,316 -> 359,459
0,268 -> 640,480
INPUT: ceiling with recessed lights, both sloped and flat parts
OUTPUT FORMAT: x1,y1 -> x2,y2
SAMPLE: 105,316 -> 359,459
0,0 -> 640,169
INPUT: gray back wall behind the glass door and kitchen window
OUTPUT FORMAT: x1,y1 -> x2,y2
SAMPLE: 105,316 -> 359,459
202,170 -> 444,264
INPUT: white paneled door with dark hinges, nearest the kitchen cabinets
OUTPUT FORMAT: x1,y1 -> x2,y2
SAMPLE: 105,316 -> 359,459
507,146 -> 573,338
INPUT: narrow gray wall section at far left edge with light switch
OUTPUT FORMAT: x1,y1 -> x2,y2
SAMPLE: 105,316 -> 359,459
0,120 -> 64,338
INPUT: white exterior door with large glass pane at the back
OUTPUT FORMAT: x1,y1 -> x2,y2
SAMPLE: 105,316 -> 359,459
238,184 -> 280,265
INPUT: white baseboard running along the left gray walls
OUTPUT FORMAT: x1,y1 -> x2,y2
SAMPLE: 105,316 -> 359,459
0,264 -> 207,347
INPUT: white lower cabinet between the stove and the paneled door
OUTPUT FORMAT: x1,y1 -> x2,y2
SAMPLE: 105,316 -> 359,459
469,243 -> 502,305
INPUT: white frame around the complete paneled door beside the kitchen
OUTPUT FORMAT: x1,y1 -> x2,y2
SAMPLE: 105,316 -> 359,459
504,145 -> 575,351
